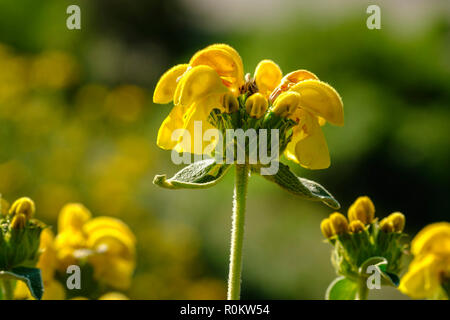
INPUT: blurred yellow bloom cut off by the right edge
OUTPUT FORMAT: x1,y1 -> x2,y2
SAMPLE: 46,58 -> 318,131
399,222 -> 450,299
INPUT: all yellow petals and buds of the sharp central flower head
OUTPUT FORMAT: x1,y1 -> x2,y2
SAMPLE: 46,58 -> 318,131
153,44 -> 344,169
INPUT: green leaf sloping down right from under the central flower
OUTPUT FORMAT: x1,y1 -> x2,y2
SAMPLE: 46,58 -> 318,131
254,162 -> 341,209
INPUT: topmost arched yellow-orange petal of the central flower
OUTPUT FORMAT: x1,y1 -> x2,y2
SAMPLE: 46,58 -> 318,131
189,44 -> 244,94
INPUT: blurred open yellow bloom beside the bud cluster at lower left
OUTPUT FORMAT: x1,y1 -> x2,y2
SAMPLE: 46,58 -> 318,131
55,204 -> 136,289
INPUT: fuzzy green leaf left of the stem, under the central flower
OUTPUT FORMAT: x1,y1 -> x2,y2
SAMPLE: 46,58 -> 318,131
153,159 -> 230,189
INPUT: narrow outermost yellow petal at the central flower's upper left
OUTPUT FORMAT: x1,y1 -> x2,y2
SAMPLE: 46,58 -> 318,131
153,64 -> 189,104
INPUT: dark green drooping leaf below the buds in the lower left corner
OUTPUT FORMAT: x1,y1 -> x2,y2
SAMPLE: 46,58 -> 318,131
0,267 -> 44,300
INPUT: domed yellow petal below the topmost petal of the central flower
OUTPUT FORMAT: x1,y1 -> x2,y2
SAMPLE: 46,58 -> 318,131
174,66 -> 229,107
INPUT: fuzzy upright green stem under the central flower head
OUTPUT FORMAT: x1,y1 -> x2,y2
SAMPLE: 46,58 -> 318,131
227,164 -> 249,300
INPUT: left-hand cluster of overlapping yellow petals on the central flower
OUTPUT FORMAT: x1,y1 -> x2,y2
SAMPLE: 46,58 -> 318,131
153,44 -> 244,154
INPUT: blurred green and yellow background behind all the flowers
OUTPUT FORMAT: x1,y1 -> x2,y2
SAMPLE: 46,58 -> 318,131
0,0 -> 450,299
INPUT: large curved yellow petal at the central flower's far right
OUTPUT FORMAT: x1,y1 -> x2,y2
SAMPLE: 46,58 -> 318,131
290,80 -> 344,126
